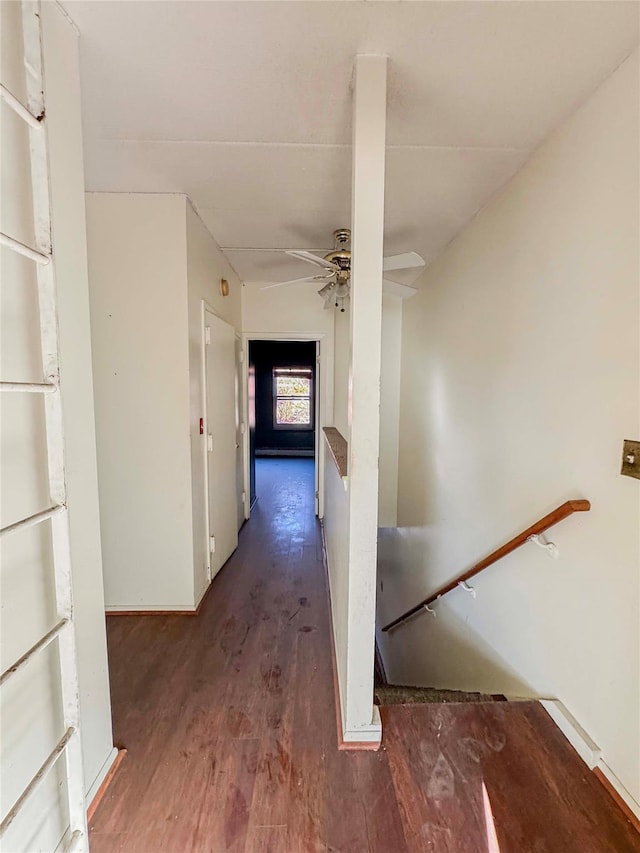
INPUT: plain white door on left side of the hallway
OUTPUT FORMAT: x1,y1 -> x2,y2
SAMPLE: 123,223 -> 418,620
204,311 -> 238,578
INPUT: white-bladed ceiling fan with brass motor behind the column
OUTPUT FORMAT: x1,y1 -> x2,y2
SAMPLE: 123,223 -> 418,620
262,228 -> 424,311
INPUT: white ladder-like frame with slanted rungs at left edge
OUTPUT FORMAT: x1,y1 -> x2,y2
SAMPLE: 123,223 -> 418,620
0,0 -> 89,851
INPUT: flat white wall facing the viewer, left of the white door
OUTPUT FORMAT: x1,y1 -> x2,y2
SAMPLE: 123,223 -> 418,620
87,193 -> 194,610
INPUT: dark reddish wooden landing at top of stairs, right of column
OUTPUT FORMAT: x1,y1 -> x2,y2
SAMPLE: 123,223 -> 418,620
374,645 -> 640,853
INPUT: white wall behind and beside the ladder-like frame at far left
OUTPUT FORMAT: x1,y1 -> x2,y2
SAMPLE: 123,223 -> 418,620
0,2 -> 114,851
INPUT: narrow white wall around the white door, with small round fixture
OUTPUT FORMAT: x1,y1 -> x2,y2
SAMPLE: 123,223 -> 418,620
184,198 -> 242,603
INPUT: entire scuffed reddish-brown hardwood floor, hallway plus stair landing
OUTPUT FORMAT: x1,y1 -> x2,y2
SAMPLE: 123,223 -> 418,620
91,459 -> 640,853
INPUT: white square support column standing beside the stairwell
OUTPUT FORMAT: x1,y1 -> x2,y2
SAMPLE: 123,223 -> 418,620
343,56 -> 387,743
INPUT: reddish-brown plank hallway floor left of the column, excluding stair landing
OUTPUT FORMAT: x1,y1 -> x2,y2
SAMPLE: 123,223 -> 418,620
91,459 -> 404,853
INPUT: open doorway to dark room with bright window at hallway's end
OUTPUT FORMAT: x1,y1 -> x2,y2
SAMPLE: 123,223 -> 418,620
248,340 -> 320,515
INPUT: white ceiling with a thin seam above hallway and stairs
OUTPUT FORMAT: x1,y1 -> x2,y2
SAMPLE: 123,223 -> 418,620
65,0 -> 640,281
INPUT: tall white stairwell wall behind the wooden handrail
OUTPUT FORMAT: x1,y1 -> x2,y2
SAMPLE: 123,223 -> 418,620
379,54 -> 640,800
